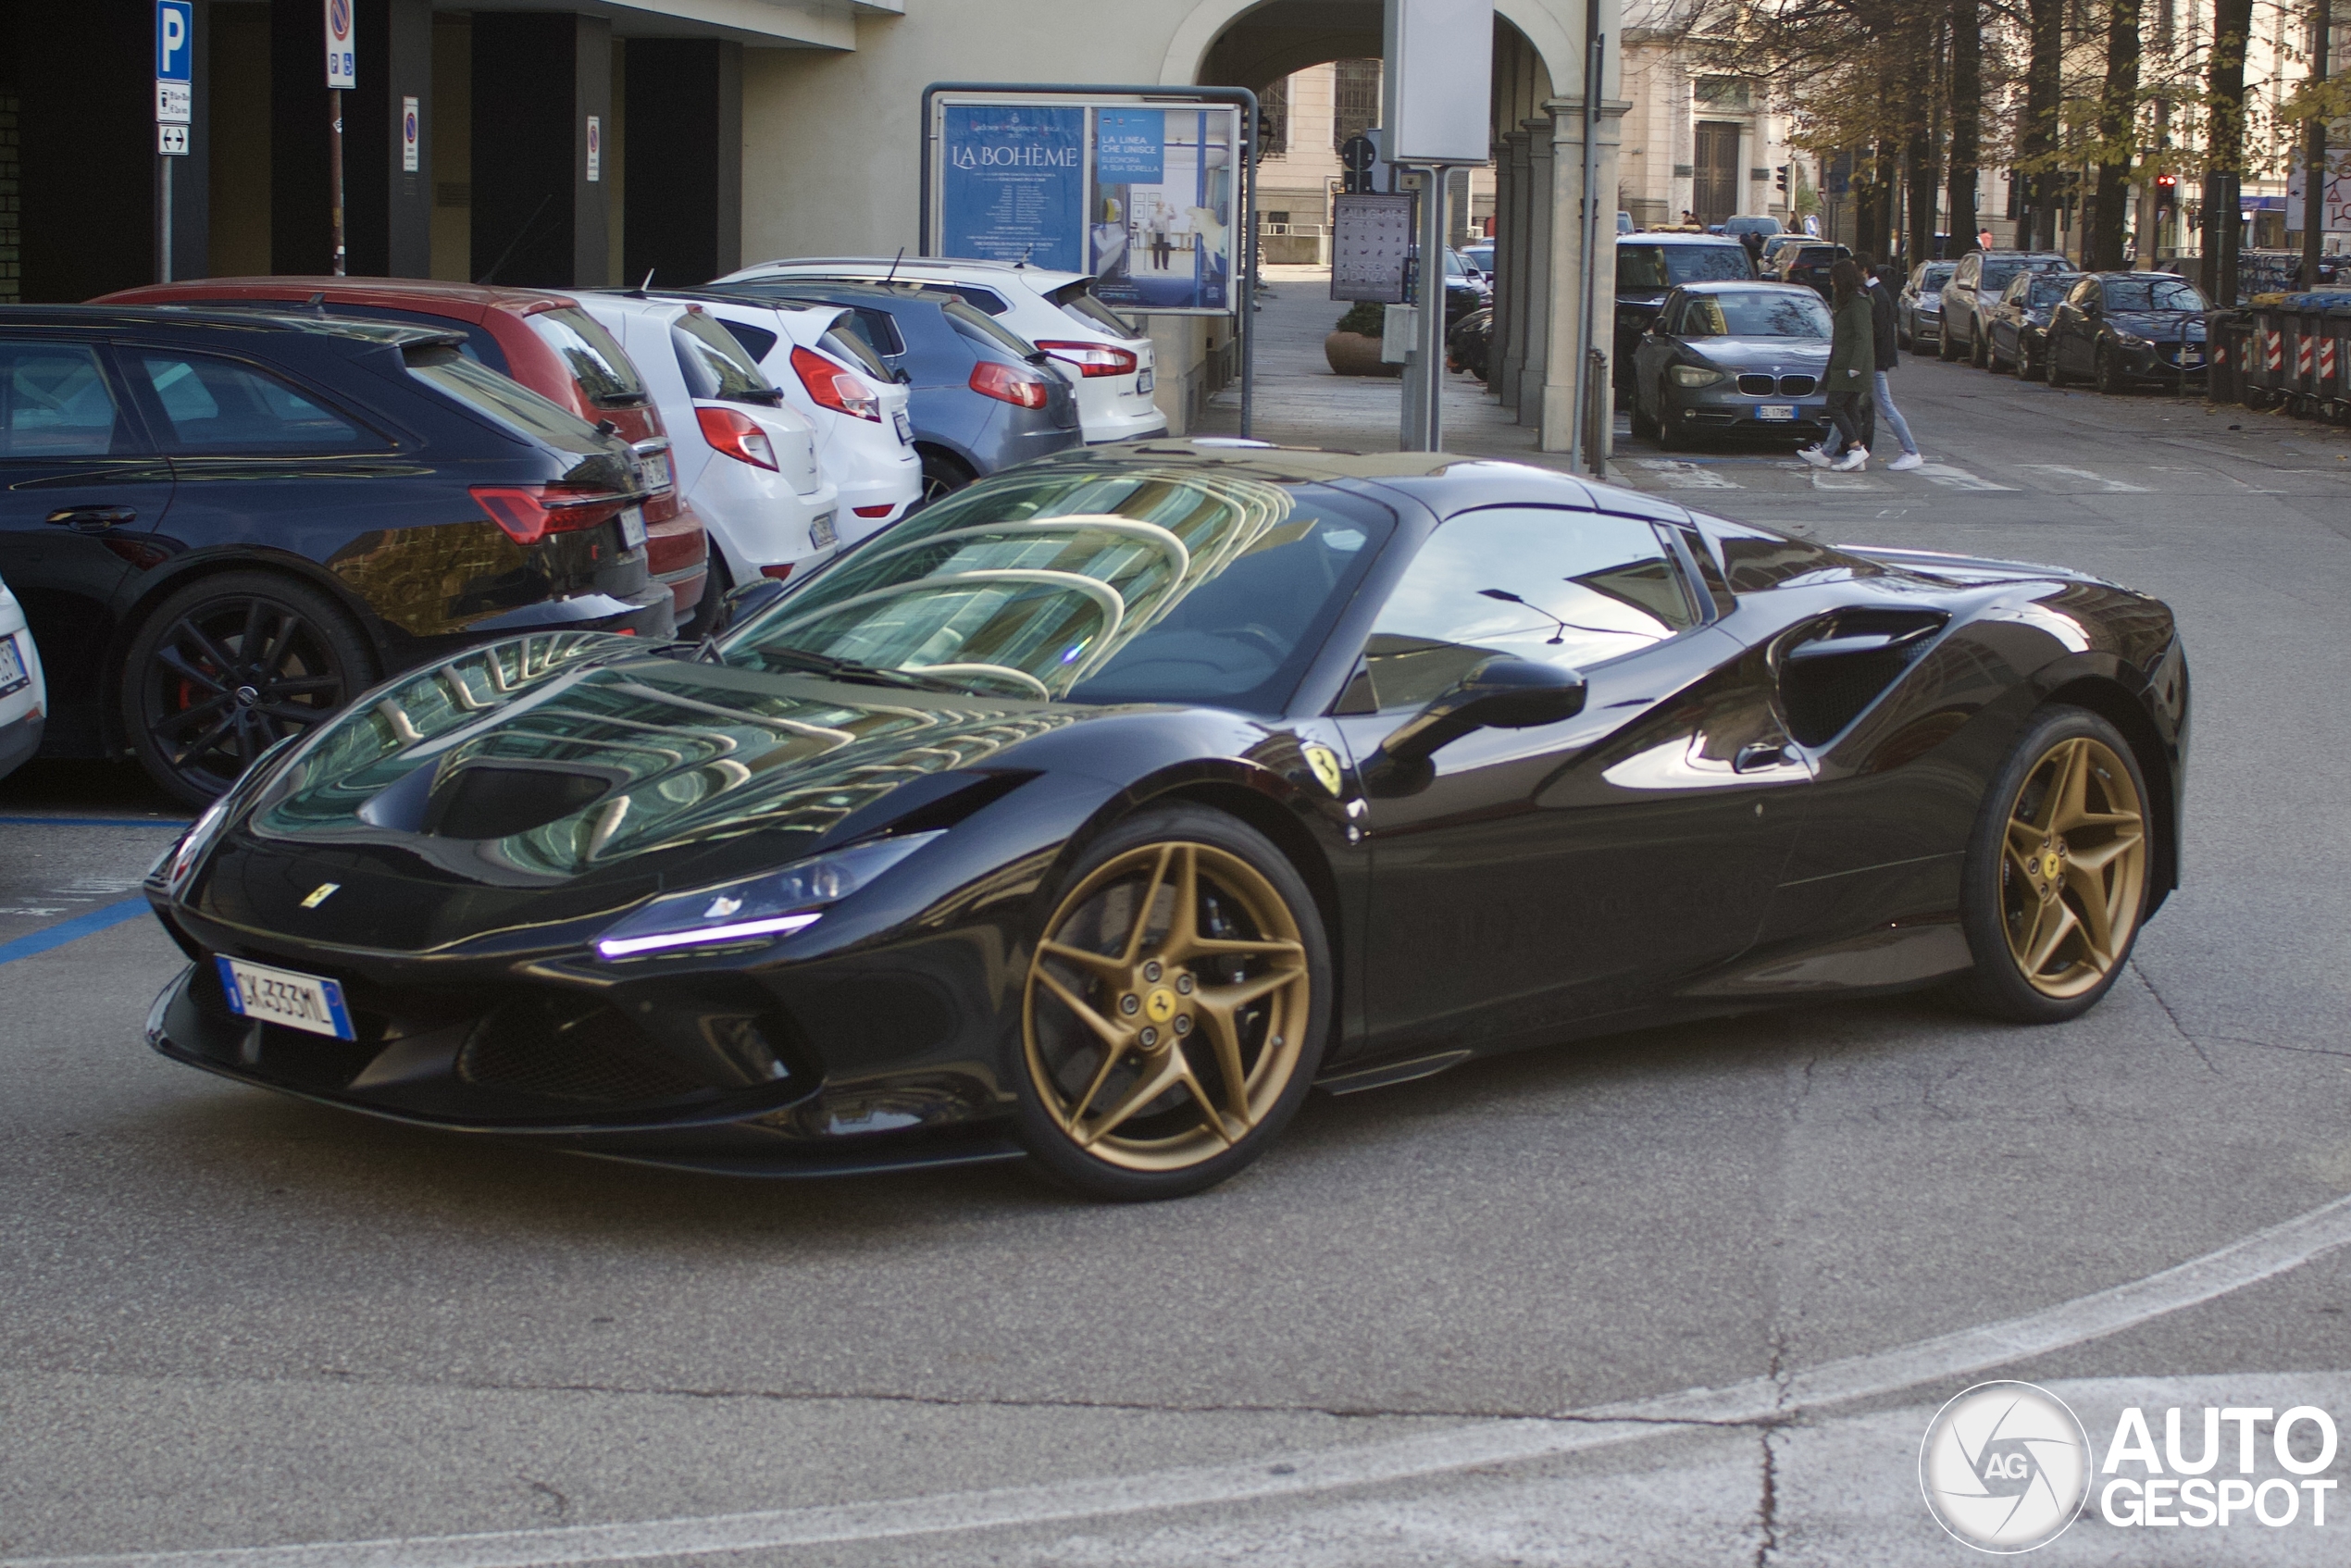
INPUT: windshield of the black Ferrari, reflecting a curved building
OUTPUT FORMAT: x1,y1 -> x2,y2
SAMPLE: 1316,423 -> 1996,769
719,466 -> 1394,713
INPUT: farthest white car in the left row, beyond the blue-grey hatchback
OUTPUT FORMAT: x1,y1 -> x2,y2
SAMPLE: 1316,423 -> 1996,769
719,256 -> 1168,442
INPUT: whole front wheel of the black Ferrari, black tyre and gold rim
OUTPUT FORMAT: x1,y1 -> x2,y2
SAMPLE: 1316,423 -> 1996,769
1006,804 -> 1333,1201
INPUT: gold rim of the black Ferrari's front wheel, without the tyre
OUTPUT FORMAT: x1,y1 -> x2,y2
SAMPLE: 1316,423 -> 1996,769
1020,840 -> 1314,1173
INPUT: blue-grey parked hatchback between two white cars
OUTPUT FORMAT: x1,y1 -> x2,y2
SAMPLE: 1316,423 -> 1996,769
713,278 -> 1086,504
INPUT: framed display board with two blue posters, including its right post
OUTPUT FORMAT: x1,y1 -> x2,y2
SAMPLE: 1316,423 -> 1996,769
919,82 -> 1258,435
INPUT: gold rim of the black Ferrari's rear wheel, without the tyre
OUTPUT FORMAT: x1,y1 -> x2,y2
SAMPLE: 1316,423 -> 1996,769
2001,736 -> 2146,999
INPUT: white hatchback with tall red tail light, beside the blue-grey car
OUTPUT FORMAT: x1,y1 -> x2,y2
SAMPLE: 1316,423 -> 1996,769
667,293 -> 922,545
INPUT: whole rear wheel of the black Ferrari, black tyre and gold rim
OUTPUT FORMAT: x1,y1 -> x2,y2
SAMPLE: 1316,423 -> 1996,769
1956,703 -> 2149,1023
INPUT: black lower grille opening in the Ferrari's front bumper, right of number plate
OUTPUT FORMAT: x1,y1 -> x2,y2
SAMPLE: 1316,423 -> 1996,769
456,994 -> 708,1107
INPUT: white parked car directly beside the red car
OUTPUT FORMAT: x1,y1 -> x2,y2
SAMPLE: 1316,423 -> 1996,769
576,292 -> 840,583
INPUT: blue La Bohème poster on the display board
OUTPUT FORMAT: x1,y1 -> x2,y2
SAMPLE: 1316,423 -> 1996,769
940,104 -> 1086,273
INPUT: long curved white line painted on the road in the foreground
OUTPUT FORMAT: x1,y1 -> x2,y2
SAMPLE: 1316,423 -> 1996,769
27,1197 -> 2351,1568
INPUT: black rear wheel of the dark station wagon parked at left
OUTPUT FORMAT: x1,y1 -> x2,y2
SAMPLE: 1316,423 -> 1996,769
122,571 -> 376,806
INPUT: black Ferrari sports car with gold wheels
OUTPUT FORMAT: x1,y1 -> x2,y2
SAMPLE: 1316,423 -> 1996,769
148,440 -> 2189,1199
